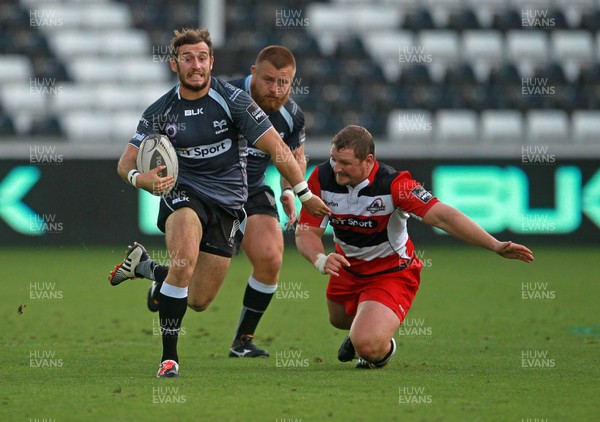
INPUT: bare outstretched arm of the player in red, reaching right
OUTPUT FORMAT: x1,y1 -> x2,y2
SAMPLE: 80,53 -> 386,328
423,202 -> 534,262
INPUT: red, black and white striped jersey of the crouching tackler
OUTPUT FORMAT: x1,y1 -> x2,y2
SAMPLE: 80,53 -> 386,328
299,161 -> 439,276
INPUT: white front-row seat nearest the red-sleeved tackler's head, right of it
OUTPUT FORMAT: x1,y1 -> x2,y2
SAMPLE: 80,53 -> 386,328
387,109 -> 433,145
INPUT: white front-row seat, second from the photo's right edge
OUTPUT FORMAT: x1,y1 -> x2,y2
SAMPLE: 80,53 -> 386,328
525,110 -> 570,145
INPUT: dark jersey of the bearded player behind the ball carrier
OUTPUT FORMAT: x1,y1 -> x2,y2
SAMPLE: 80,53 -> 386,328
230,75 -> 305,193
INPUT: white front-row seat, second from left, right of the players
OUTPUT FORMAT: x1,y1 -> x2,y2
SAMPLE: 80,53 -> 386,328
434,109 -> 479,145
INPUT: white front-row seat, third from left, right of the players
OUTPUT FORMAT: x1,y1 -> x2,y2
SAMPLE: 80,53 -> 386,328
480,110 -> 523,145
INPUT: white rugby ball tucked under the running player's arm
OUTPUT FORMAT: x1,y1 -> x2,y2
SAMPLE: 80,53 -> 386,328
136,134 -> 179,195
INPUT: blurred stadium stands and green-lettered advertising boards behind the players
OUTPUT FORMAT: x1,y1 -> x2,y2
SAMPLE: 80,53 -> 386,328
0,0 -> 600,244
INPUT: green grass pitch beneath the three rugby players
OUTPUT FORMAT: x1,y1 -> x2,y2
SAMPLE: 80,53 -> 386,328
0,247 -> 600,422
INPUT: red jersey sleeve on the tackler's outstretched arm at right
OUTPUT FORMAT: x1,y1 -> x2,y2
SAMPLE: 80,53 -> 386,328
391,171 -> 440,218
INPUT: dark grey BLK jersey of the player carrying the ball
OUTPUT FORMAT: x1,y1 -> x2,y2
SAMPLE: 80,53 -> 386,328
129,77 -> 272,209
